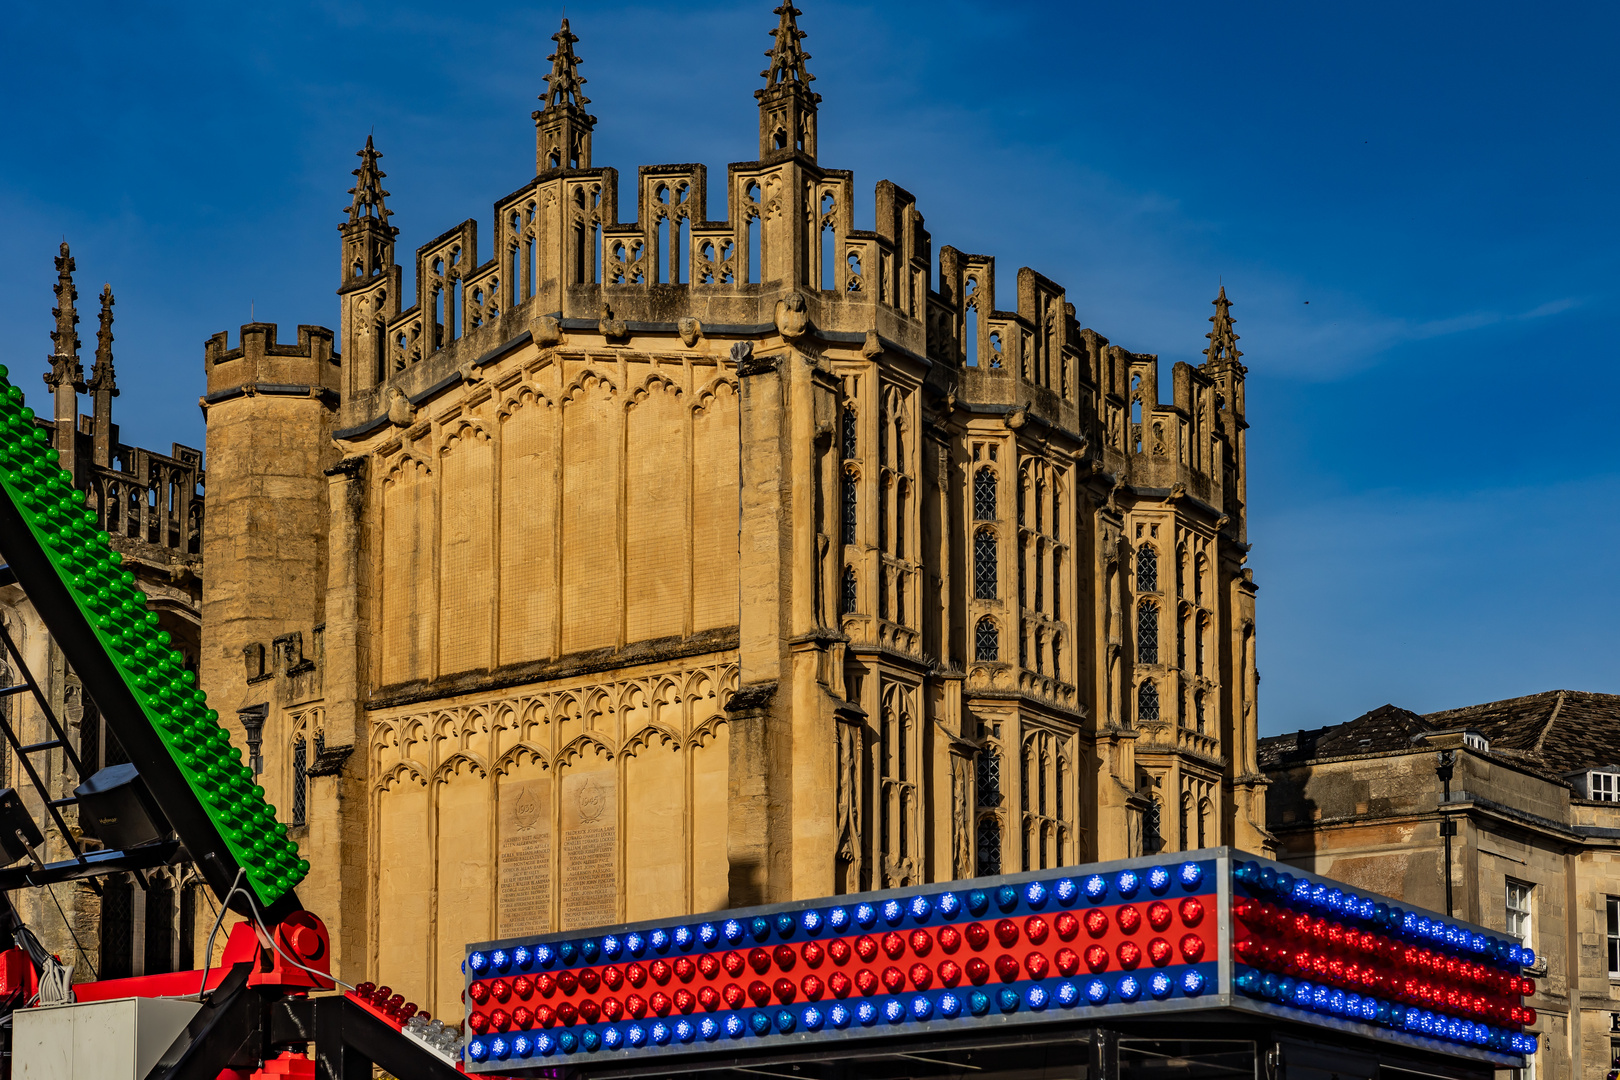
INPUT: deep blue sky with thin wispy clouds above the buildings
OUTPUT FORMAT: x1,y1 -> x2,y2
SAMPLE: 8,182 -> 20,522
0,0 -> 1620,733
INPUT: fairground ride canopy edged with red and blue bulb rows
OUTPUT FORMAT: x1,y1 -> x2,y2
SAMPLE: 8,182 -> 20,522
463,848 -> 1536,1074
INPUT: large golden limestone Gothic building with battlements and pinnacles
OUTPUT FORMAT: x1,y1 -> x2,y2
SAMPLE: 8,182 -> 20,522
201,5 -> 1270,1014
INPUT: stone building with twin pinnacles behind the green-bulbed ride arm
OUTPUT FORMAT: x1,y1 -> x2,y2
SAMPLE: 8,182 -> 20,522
0,243 -> 206,980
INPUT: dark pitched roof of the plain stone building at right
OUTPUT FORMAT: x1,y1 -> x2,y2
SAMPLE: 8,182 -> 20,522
1259,690 -> 1620,777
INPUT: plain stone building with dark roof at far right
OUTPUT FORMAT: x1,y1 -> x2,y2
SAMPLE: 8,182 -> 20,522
1260,690 -> 1620,1080
